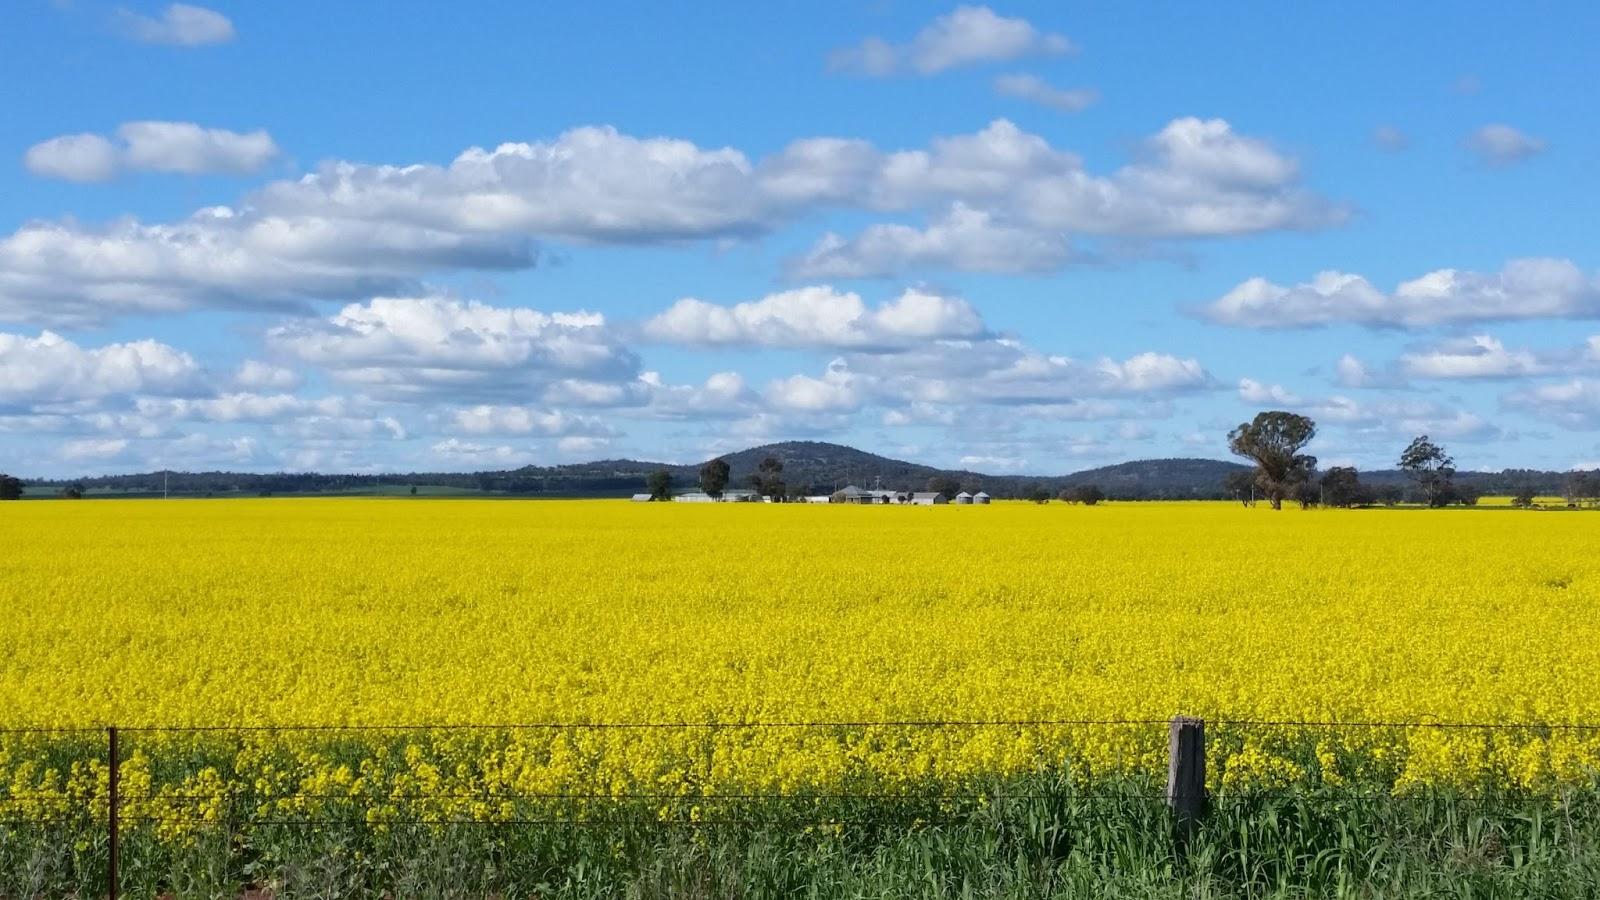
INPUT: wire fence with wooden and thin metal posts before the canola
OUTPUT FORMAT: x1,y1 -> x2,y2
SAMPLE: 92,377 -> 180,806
0,716 -> 1600,898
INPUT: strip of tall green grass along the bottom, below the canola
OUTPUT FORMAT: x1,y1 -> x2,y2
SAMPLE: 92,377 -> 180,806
0,775 -> 1600,900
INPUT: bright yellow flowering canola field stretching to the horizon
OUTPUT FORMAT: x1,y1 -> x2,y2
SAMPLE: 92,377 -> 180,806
0,500 -> 1600,818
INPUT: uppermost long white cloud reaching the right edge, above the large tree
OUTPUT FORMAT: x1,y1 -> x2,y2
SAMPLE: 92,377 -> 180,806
1203,258 -> 1600,328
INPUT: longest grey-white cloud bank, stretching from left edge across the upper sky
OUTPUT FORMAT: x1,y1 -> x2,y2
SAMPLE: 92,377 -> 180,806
0,119 -> 1344,318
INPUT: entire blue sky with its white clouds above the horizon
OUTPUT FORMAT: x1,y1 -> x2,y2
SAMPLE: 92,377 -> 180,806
0,0 -> 1600,476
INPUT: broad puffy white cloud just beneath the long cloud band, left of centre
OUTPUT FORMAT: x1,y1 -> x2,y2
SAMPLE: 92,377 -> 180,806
267,296 -> 638,399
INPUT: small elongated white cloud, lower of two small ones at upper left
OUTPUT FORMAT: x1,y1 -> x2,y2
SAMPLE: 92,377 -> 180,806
22,122 -> 278,181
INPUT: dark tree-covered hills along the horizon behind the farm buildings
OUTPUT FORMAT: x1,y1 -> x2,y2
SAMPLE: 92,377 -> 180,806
12,440 -> 1565,500
